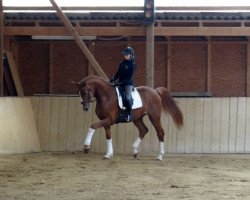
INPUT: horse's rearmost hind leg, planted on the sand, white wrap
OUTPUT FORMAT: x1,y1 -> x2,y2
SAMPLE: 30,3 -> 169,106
149,117 -> 165,161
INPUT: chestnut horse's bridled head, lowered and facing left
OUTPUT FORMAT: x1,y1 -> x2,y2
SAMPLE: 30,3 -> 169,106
72,81 -> 95,111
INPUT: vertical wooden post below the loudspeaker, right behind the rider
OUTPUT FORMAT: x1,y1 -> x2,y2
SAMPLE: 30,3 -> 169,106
146,24 -> 154,88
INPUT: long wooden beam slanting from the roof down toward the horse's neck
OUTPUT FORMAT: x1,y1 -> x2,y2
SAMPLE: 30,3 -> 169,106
50,0 -> 108,80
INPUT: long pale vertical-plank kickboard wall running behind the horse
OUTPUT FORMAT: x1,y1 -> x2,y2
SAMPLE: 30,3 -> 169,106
31,96 -> 250,154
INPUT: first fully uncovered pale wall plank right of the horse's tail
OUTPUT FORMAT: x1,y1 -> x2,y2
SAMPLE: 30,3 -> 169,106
185,98 -> 195,153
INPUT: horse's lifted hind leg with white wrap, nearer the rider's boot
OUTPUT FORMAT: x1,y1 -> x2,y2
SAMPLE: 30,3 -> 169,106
133,117 -> 148,158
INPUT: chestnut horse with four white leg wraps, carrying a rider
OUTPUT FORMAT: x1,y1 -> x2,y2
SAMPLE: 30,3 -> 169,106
72,76 -> 183,160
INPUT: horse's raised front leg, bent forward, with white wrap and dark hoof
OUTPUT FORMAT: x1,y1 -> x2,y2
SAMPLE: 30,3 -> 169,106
84,118 -> 111,153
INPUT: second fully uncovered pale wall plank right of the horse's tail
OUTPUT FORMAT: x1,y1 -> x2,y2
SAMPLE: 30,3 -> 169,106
194,98 -> 204,153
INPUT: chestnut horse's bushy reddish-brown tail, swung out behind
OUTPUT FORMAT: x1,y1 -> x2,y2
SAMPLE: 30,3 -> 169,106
155,87 -> 183,128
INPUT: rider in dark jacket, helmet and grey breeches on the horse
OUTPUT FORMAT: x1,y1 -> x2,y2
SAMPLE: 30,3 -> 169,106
110,47 -> 136,121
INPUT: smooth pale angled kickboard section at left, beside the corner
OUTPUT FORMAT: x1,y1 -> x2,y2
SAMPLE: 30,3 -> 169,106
0,97 -> 40,154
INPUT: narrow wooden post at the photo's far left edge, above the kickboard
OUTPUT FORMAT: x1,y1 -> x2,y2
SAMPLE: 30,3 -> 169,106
0,0 -> 4,96
